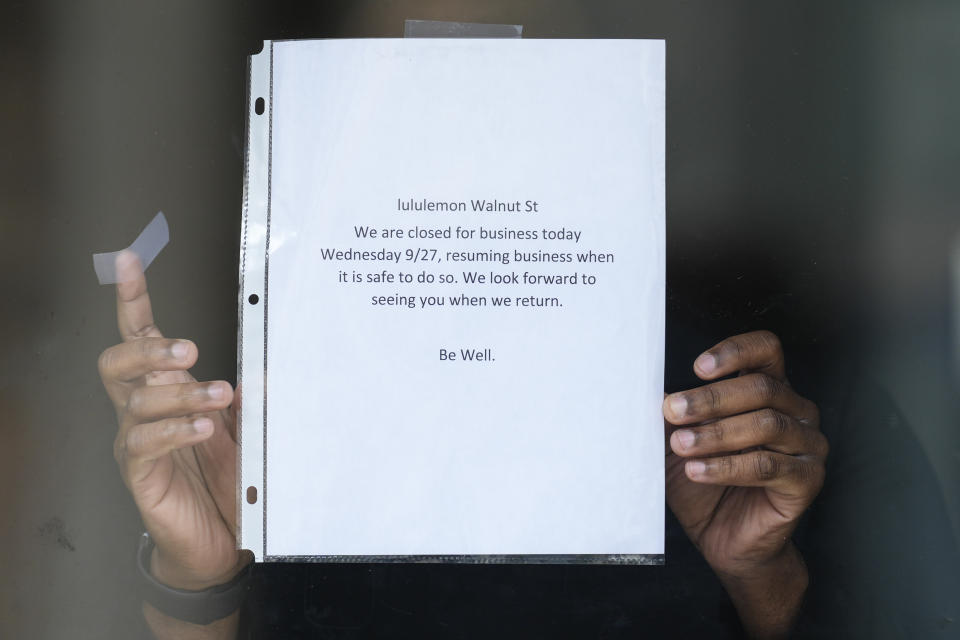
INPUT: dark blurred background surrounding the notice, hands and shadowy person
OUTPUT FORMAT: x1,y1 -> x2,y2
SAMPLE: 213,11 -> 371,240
0,0 -> 960,638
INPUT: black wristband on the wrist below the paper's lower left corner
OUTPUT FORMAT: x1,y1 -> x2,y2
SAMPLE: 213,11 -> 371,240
137,533 -> 253,625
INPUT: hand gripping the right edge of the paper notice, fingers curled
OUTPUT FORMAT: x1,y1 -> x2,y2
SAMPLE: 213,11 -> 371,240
663,331 -> 828,626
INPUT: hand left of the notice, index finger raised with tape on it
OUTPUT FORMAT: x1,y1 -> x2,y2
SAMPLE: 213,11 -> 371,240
99,252 -> 248,590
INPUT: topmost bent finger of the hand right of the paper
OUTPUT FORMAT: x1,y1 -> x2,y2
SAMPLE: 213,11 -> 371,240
693,331 -> 787,382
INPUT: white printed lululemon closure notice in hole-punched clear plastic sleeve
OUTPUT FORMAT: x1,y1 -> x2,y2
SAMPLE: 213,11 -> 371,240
239,39 -> 665,561
